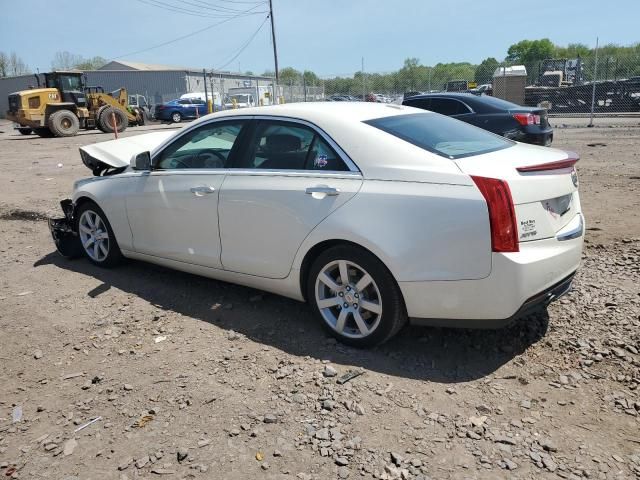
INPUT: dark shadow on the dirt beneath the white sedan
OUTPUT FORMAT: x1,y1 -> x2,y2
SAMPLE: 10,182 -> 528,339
34,252 -> 549,383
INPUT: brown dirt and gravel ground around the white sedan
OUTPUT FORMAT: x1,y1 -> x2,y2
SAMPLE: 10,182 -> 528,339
0,119 -> 640,480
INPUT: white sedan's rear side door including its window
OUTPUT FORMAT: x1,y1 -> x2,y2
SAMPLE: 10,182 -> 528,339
219,117 -> 362,278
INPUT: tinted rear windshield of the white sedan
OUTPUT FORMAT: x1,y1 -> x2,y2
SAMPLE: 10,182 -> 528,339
364,113 -> 515,159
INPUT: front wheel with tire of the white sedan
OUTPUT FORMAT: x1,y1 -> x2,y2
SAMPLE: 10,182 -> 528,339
76,201 -> 124,268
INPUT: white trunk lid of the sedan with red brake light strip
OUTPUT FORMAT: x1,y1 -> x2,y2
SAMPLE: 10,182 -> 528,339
455,144 -> 581,242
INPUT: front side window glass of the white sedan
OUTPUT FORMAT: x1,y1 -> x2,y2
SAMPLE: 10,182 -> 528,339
154,121 -> 244,170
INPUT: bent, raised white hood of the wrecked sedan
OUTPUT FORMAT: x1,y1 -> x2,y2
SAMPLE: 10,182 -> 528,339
80,130 -> 176,173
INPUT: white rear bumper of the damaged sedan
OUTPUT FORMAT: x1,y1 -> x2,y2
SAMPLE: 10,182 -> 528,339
399,232 -> 583,328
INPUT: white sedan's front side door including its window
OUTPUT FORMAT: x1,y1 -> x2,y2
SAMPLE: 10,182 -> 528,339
127,121 -> 244,268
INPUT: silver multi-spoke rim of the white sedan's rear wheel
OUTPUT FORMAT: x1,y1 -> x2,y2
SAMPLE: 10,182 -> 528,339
315,260 -> 382,339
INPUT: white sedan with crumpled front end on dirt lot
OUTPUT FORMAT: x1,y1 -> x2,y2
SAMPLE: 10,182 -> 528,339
50,102 -> 584,346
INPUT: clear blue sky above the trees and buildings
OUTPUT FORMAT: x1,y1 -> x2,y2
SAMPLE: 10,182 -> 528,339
0,0 -> 640,76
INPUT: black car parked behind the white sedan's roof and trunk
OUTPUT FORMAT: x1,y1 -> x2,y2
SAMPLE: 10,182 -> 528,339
402,93 -> 553,145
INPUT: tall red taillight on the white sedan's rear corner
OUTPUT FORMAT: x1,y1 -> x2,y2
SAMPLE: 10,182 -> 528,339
471,175 -> 520,252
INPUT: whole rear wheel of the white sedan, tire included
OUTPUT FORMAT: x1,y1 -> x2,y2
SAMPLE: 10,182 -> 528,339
307,245 -> 407,347
